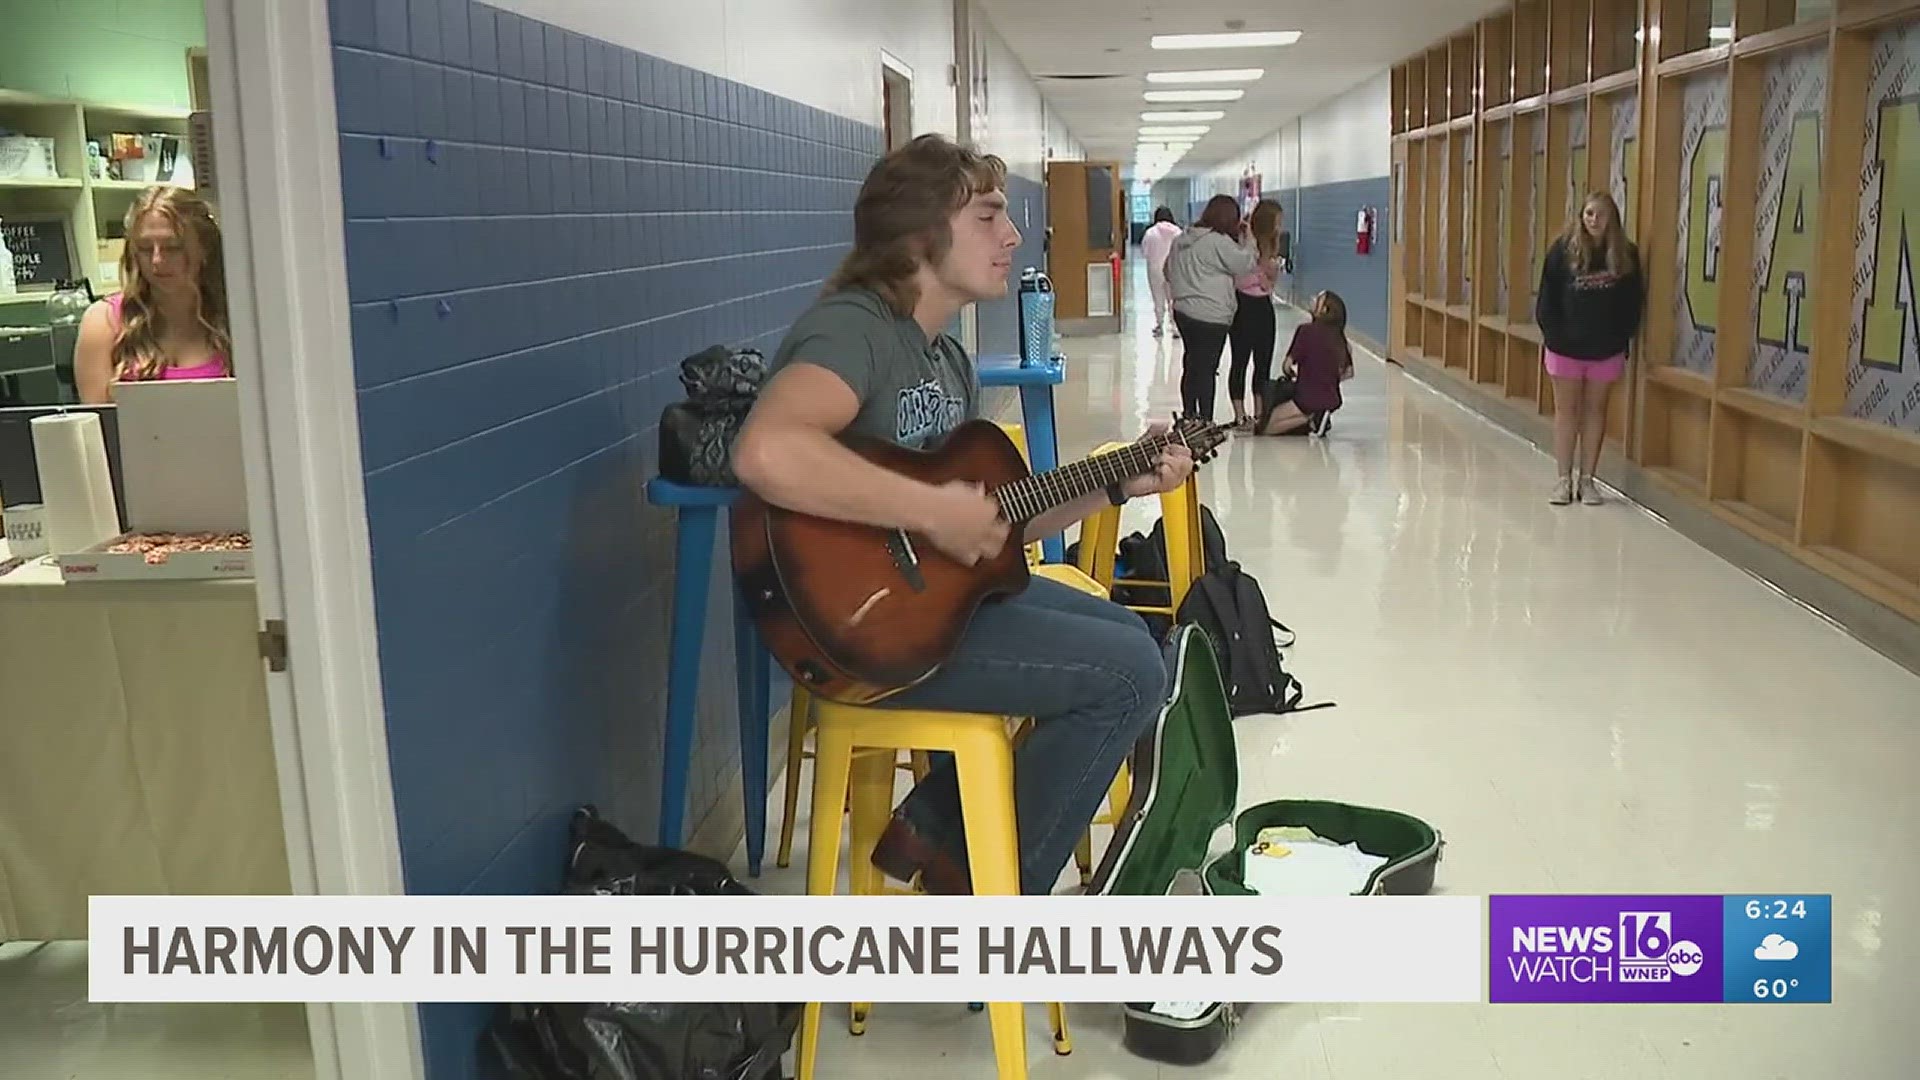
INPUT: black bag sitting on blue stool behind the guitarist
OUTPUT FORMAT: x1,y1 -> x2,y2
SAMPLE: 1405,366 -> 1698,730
660,346 -> 766,488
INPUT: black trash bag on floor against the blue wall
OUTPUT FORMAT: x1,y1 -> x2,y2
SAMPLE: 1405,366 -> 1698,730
484,807 -> 801,1080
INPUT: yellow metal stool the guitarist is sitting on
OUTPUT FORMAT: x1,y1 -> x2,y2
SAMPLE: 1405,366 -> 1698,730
797,700 -> 1073,1080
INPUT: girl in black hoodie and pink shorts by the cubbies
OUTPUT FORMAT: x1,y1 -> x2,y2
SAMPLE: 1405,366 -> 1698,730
1534,192 -> 1645,505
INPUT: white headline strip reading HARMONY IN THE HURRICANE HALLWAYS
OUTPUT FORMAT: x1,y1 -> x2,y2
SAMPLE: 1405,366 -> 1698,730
88,896 -> 1486,1001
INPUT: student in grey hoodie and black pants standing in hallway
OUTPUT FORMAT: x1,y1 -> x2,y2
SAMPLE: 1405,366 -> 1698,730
1167,194 -> 1258,423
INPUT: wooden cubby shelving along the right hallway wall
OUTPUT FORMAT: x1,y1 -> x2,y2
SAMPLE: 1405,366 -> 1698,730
1390,0 -> 1920,621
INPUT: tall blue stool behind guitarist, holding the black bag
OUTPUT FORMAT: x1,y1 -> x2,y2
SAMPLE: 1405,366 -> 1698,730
647,477 -> 772,876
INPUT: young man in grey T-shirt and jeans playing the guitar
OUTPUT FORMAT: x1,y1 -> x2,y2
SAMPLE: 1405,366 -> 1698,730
733,135 -> 1194,894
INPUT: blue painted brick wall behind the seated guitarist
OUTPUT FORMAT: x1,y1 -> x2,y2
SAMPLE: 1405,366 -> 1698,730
330,0 -> 879,1080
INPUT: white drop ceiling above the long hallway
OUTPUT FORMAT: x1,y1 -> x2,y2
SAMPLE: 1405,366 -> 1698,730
981,0 -> 1507,175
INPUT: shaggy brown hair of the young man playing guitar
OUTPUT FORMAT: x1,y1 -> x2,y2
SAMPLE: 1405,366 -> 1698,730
826,135 -> 1006,317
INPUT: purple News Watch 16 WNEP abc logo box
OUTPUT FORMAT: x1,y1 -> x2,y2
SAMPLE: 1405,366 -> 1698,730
1490,896 -> 1722,1003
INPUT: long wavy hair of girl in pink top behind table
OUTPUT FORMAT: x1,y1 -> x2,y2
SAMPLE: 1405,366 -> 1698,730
113,184 -> 234,382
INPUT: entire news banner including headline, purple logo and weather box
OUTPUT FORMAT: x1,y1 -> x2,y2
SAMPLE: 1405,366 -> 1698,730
88,894 -> 1834,1003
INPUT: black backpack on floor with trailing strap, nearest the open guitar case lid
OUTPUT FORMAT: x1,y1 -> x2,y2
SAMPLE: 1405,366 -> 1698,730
1179,561 -> 1332,717
